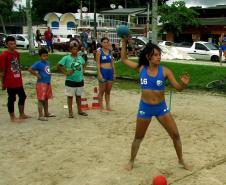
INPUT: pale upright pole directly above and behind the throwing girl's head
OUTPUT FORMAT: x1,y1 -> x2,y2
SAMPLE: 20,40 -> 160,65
151,0 -> 158,44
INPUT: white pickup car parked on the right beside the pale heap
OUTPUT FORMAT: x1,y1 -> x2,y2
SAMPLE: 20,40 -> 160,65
177,41 -> 219,62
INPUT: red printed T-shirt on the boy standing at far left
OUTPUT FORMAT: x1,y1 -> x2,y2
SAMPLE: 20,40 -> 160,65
0,51 -> 23,88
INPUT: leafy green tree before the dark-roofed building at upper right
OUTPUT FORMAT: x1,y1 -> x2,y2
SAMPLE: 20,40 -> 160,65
159,1 -> 200,35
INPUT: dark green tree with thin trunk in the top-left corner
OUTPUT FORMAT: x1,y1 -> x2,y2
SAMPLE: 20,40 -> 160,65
0,0 -> 14,34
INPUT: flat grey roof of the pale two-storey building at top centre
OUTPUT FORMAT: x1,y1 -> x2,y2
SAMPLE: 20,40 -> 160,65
100,8 -> 146,15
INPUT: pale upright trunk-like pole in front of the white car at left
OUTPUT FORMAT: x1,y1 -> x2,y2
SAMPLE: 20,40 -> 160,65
26,0 -> 35,55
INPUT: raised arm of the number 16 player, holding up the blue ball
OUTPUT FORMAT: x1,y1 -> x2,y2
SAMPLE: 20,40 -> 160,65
121,38 -> 139,71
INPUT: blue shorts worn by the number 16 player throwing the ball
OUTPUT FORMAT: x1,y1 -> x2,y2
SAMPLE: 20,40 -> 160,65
137,100 -> 169,119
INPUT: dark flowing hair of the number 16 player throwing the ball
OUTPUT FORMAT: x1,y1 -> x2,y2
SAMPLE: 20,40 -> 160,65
138,42 -> 162,67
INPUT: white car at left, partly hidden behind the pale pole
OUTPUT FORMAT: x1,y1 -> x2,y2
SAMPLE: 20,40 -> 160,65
10,34 -> 47,49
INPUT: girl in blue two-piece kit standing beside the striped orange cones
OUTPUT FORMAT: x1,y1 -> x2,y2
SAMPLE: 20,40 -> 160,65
96,37 -> 115,112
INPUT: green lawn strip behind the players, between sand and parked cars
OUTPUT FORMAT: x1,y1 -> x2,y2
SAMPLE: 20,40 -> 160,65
1,52 -> 226,90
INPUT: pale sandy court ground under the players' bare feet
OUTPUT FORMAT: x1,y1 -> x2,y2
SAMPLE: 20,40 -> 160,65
0,73 -> 226,185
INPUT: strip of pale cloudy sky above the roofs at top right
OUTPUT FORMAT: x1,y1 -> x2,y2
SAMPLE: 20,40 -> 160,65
167,0 -> 226,7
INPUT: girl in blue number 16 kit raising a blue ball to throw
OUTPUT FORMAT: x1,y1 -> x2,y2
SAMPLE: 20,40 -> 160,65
121,38 -> 189,170
